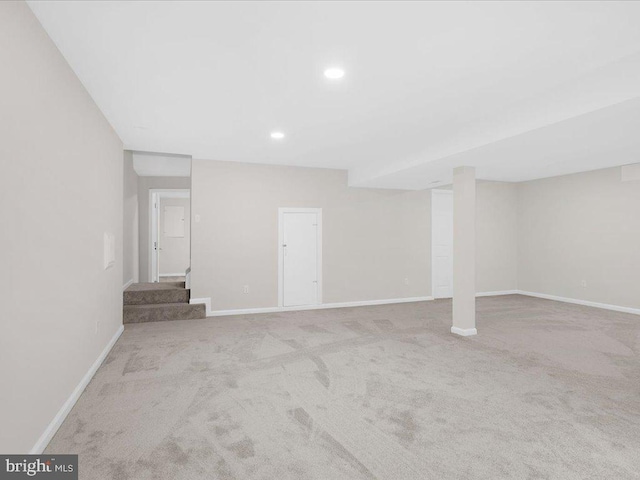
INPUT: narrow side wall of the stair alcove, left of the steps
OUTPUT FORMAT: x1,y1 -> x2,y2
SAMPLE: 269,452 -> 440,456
122,150 -> 140,285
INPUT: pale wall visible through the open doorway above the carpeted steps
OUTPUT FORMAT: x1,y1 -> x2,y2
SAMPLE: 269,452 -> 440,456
160,198 -> 191,275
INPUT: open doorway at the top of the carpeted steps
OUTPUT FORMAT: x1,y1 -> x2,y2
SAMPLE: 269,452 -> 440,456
149,189 -> 191,282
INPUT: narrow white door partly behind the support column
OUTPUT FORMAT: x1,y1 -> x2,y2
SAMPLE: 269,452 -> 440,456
431,190 -> 453,298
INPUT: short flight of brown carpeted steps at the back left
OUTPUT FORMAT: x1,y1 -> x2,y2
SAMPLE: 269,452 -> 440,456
123,282 -> 206,323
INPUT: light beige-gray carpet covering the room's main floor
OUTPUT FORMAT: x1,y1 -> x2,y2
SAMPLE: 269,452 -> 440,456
47,295 -> 640,480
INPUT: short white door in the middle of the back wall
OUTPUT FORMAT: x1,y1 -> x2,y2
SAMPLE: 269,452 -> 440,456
281,212 -> 319,307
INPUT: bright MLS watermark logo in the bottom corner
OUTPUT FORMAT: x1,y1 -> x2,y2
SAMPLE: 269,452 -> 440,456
0,455 -> 78,480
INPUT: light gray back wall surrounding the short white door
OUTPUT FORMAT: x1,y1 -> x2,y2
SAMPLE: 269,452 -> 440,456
191,160 -> 431,310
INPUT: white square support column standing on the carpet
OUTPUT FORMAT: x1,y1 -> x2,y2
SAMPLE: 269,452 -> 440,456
451,167 -> 478,336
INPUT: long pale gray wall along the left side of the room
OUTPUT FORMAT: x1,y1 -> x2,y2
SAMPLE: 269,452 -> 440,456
0,2 -> 123,453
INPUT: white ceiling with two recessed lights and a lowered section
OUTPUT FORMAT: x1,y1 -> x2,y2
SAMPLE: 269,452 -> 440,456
29,1 -> 640,189
